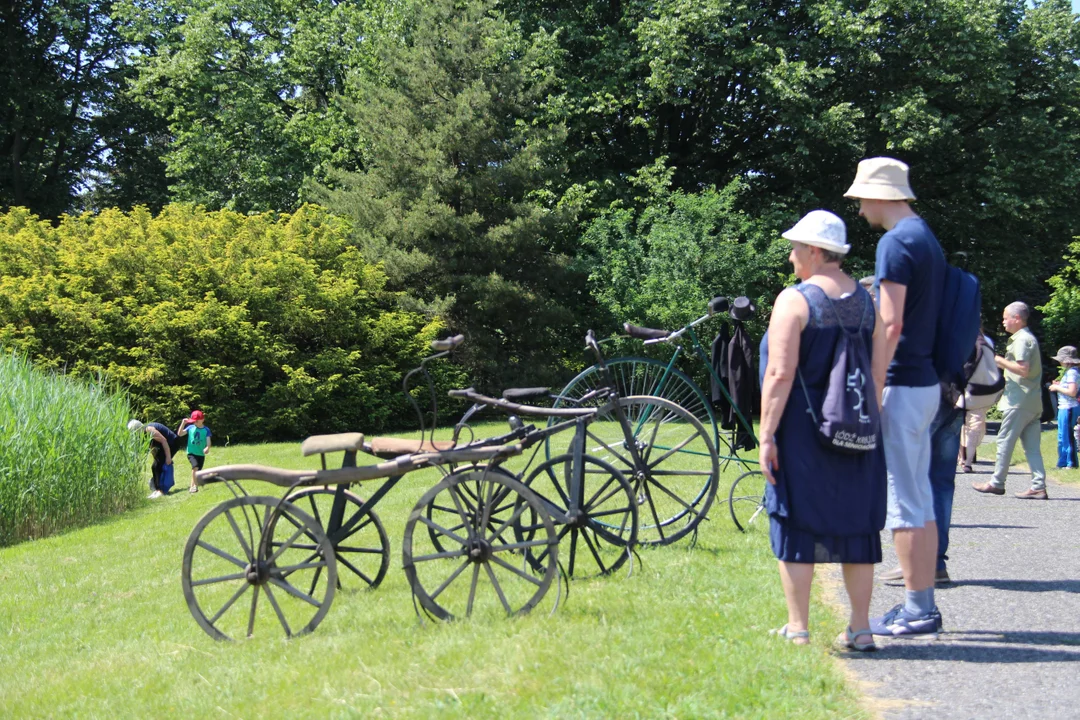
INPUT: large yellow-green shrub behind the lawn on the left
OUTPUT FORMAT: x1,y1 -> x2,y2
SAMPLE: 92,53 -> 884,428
0,205 -> 459,441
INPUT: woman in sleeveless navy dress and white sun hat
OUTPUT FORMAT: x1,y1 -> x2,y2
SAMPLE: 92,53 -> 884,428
758,210 -> 886,651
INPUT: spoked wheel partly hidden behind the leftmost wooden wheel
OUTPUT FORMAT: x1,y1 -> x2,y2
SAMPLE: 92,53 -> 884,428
288,488 -> 390,589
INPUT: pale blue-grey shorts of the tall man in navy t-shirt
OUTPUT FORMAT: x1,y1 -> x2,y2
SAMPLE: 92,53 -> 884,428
881,385 -> 941,530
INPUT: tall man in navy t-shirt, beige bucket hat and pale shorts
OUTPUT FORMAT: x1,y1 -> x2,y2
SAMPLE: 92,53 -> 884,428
845,158 -> 945,636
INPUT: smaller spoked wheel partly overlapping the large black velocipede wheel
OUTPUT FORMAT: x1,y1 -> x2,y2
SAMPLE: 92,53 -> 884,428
515,453 -> 638,580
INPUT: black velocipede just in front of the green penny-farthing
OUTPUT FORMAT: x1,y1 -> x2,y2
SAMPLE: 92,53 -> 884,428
451,330 -> 719,548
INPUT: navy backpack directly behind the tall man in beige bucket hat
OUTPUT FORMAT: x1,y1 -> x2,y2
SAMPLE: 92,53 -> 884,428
933,264 -> 983,392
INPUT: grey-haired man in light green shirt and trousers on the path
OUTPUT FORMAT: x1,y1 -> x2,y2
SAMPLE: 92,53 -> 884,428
971,302 -> 1047,500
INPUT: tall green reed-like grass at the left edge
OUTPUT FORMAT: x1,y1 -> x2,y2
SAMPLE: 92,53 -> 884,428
0,353 -> 148,546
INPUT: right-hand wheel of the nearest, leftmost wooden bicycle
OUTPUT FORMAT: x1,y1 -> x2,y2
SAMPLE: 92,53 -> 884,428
402,468 -> 558,620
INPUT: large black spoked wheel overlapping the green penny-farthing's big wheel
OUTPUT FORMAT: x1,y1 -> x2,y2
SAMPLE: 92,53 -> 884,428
552,396 -> 720,545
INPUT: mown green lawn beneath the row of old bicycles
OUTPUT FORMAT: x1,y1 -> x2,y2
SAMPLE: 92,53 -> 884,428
0,425 -> 863,719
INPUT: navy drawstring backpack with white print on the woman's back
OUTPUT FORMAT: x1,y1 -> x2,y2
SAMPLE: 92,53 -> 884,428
798,287 -> 881,454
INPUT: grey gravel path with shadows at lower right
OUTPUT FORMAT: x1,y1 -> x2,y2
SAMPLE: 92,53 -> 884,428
840,445 -> 1080,720
